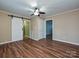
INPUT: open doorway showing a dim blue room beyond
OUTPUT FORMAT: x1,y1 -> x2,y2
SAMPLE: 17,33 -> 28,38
46,20 -> 53,40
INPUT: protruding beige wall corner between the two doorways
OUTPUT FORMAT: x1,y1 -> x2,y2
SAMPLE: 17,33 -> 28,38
31,16 -> 44,40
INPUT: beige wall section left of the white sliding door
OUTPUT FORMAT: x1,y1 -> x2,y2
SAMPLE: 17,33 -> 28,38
0,12 -> 11,43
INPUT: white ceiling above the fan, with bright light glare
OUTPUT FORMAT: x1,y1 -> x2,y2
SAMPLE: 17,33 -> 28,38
0,0 -> 79,17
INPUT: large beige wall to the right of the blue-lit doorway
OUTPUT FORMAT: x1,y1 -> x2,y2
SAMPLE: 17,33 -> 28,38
52,10 -> 79,45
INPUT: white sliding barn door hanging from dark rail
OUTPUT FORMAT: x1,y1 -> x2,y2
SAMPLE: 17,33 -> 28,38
12,17 -> 23,41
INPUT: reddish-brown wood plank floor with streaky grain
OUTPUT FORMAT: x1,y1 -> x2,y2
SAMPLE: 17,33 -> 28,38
0,39 -> 79,58
